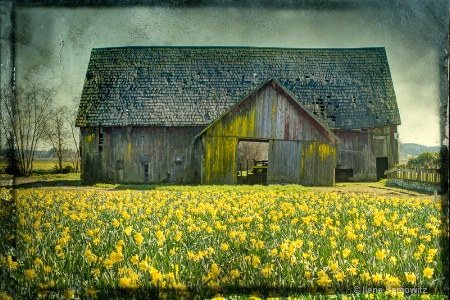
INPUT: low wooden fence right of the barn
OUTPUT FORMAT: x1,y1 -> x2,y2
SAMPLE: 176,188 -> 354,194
384,165 -> 441,183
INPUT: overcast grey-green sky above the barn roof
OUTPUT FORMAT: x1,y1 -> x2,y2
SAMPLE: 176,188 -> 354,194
7,0 -> 448,145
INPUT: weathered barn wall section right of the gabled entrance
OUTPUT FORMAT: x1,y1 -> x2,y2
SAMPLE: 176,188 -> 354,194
334,126 -> 398,181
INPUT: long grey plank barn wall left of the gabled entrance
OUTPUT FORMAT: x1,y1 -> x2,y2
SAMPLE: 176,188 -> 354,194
81,127 -> 203,183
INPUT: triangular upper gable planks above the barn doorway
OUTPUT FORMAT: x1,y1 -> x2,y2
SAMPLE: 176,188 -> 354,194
206,83 -> 334,143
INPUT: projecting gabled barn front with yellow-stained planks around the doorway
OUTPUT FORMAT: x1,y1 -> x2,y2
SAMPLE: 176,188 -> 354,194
197,79 -> 340,185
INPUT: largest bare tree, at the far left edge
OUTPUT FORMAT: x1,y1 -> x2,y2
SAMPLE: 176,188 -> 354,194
0,85 -> 55,176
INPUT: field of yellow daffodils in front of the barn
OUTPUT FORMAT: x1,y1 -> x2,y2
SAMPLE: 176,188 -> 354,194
0,186 -> 448,299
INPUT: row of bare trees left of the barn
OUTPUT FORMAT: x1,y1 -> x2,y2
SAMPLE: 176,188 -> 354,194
0,84 -> 80,176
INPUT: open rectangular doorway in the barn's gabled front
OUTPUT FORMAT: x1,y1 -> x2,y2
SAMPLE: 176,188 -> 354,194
236,140 -> 269,185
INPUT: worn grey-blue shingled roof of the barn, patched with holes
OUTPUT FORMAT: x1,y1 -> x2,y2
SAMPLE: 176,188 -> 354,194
76,47 -> 400,129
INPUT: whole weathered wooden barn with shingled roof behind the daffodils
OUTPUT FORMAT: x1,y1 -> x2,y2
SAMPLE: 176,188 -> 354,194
76,47 -> 400,185
